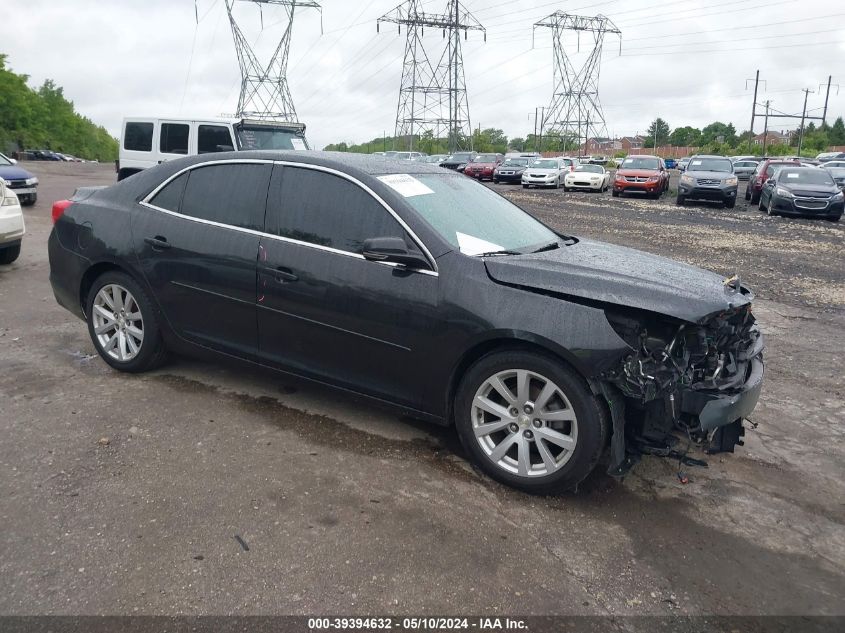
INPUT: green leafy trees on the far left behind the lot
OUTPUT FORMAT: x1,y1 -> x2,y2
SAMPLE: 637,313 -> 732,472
0,53 -> 118,161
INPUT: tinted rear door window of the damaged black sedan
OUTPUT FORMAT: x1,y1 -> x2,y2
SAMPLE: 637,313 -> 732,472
178,163 -> 272,231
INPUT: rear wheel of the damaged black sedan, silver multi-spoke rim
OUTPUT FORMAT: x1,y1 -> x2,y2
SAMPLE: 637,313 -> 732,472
85,271 -> 166,373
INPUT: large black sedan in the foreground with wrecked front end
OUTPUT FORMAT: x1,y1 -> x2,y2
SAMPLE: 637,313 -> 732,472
49,151 -> 763,492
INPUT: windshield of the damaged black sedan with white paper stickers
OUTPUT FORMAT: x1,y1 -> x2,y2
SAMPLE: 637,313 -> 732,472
398,174 -> 559,255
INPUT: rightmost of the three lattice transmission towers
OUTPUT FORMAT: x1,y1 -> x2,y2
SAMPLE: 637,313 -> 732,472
532,11 -> 622,150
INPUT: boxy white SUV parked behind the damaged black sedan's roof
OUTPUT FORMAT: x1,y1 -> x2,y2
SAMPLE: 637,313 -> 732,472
115,117 -> 309,180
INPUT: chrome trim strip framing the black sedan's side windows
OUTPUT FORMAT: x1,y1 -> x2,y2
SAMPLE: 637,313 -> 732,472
138,158 -> 440,277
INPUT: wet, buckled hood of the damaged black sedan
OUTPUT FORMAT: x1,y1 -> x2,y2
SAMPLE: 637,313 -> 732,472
485,239 -> 753,323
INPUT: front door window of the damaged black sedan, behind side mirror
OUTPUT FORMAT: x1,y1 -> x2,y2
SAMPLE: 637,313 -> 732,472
267,167 -> 414,254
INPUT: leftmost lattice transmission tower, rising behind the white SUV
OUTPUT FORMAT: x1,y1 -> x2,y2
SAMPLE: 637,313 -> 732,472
226,0 -> 322,121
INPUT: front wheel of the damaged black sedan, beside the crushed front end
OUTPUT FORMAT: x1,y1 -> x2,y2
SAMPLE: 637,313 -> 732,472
455,351 -> 608,494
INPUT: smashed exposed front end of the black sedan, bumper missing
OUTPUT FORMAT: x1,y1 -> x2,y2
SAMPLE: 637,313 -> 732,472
599,303 -> 764,476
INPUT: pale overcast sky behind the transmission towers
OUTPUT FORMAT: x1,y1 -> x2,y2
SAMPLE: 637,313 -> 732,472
6,0 -> 845,148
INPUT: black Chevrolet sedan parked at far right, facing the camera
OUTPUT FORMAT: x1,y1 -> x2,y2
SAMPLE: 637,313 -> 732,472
760,167 -> 845,222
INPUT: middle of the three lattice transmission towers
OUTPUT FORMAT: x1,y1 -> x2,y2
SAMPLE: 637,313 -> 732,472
376,0 -> 487,152
